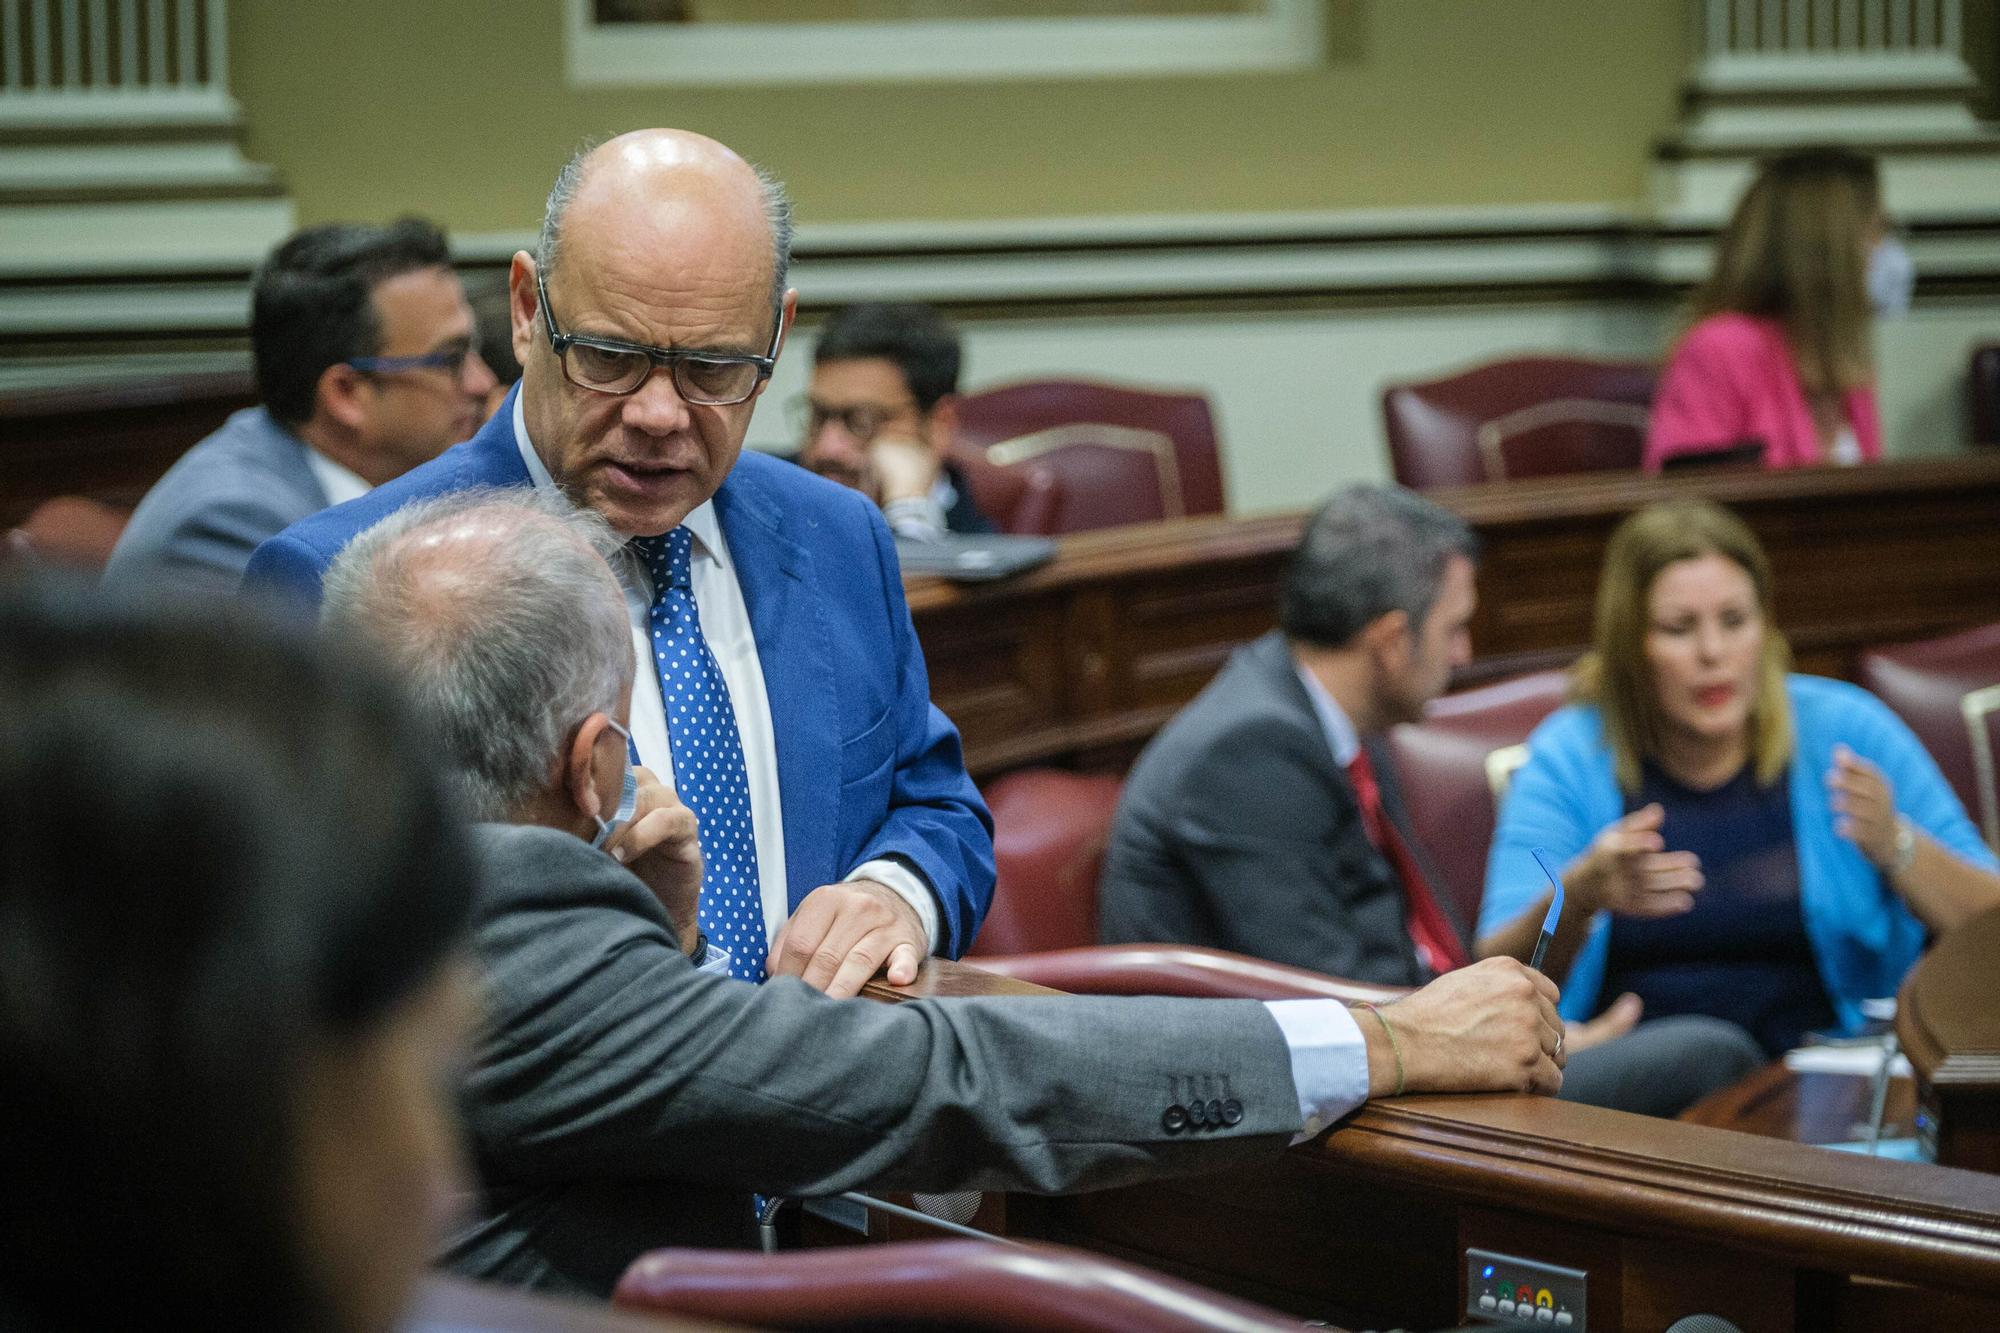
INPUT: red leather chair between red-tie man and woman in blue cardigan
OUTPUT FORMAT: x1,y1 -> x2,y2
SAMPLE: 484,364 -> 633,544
1390,671 -> 1568,923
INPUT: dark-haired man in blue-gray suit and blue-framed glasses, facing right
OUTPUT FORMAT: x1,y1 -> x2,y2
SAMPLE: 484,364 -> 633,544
104,218 -> 494,594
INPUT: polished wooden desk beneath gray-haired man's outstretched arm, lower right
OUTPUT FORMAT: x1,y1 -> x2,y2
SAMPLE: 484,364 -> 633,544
870,963 -> 2000,1333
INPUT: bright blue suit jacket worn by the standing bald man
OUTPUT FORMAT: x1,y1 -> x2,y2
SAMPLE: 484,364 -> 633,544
244,388 -> 994,957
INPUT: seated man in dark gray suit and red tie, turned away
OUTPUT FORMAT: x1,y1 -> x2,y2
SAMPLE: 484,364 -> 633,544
1098,486 -> 1762,1115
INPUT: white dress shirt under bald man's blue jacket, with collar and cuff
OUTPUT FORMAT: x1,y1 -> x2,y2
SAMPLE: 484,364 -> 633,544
514,394 -> 940,951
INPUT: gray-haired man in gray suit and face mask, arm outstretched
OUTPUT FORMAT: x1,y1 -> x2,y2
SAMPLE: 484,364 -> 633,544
326,490 -> 1562,1293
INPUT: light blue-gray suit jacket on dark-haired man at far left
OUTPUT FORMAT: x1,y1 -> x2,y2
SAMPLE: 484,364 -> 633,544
104,406 -> 326,596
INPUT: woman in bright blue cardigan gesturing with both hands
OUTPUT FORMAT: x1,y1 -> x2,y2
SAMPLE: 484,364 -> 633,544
1478,500 -> 2000,1055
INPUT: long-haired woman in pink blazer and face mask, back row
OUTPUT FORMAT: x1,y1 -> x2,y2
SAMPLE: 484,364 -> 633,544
1644,148 -> 1914,472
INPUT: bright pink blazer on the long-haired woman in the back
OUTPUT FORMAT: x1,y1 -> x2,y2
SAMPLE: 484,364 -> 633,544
1644,312 -> 1882,472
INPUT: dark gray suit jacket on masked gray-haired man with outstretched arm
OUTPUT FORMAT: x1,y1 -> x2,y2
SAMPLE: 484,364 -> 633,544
448,825 -> 1300,1295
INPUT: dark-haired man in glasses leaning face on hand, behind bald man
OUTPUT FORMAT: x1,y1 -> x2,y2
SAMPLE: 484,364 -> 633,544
794,304 -> 994,540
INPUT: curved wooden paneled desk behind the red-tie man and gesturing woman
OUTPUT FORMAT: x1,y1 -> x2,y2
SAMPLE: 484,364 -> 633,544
908,454 -> 2000,777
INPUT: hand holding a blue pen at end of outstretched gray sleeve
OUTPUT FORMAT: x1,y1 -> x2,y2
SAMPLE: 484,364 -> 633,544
1354,959 -> 1568,1097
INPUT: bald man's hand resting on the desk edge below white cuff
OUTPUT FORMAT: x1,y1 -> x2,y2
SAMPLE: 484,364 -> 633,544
770,879 -> 930,999
